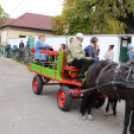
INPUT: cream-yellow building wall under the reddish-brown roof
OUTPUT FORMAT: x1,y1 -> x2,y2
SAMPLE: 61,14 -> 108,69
1,27 -> 55,45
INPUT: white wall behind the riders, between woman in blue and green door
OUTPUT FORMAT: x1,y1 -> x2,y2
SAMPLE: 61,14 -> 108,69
45,35 -> 120,62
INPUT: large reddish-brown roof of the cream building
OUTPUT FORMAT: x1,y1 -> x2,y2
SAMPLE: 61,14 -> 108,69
1,13 -> 52,31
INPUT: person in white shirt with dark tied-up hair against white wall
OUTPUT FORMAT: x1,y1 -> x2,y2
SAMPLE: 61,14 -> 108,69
104,45 -> 114,62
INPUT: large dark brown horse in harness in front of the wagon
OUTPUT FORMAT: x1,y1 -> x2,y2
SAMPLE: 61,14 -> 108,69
81,61 -> 134,134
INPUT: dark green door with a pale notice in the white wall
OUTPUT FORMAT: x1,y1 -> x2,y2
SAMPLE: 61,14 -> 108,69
119,37 -> 132,63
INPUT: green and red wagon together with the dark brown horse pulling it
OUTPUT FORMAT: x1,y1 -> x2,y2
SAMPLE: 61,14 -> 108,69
27,50 -> 134,134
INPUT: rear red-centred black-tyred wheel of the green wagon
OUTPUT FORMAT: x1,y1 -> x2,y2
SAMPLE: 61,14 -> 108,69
32,75 -> 43,95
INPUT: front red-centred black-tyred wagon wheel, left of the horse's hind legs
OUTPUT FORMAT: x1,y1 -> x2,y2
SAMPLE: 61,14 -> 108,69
57,86 -> 72,111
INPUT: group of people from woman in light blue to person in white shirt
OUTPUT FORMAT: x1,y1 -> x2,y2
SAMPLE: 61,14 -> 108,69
35,33 -> 114,81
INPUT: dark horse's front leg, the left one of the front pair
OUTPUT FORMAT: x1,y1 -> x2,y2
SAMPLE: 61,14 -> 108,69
123,101 -> 133,134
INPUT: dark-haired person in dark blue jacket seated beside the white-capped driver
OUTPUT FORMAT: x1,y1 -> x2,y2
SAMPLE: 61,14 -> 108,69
84,37 -> 100,62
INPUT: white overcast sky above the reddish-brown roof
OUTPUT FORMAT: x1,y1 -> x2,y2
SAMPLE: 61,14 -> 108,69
0,0 -> 64,18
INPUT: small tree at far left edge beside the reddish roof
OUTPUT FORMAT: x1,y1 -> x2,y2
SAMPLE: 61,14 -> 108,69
0,5 -> 9,26
